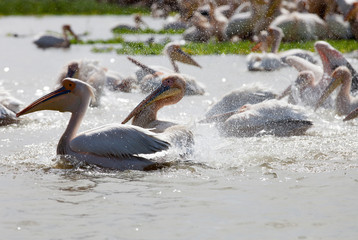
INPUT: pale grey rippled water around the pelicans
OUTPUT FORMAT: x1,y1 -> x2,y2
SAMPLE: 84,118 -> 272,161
0,16 -> 358,239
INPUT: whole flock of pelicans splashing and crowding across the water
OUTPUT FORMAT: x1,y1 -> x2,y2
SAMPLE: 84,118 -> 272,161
4,0 -> 358,170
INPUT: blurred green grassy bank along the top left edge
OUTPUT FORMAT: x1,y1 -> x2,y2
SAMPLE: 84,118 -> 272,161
0,0 -> 150,15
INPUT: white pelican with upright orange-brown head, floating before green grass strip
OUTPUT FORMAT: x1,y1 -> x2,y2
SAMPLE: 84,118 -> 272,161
247,27 -> 316,71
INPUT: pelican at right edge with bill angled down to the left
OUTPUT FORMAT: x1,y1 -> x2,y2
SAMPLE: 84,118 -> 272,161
316,66 -> 358,116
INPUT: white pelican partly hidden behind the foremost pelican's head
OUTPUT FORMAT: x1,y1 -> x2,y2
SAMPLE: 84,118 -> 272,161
57,59 -> 106,107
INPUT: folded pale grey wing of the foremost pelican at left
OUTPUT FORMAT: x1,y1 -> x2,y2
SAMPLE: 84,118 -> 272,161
71,124 -> 170,158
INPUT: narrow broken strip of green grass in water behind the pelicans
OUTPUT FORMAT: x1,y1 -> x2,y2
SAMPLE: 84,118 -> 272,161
86,37 -> 358,55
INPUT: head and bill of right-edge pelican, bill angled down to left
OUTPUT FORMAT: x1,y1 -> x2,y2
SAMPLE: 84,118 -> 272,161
315,66 -> 352,110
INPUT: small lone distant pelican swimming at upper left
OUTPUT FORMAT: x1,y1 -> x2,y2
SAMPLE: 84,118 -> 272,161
34,25 -> 78,49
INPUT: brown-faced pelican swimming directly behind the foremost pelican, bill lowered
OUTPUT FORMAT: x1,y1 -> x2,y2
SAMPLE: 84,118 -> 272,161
122,74 -> 194,147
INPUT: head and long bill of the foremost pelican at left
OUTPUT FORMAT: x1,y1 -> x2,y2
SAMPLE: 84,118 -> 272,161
16,78 -> 94,117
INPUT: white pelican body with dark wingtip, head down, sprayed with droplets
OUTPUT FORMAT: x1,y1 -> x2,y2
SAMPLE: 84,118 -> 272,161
204,99 -> 312,137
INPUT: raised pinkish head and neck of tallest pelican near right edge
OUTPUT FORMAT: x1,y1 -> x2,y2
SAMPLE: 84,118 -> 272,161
315,41 -> 358,92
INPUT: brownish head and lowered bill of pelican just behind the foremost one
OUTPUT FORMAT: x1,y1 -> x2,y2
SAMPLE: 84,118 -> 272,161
122,74 -> 185,124
